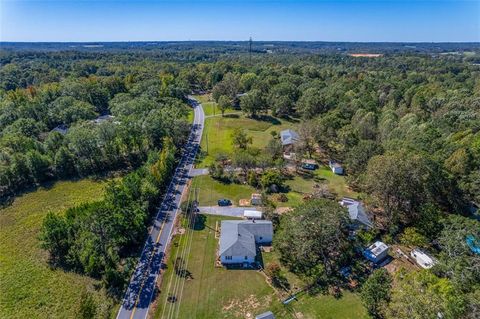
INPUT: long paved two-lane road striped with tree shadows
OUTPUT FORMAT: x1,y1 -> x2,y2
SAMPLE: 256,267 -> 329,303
117,100 -> 205,319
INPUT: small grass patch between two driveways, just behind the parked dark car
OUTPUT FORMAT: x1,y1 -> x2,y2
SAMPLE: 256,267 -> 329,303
193,175 -> 256,206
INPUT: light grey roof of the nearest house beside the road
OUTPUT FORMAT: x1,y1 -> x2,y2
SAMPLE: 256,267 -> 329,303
218,220 -> 273,256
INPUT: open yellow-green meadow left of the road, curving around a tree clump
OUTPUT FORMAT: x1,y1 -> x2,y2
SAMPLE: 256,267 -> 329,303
0,180 -> 116,319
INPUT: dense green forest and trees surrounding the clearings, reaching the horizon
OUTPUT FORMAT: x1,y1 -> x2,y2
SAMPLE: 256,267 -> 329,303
0,46 -> 480,318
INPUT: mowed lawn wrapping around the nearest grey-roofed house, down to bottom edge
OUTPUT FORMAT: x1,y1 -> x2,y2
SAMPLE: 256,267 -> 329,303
154,215 -> 365,319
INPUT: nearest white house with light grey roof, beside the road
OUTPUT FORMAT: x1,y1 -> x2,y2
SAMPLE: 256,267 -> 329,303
218,220 -> 273,264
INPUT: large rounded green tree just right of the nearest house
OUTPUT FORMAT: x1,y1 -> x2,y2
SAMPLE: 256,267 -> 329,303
274,199 -> 351,283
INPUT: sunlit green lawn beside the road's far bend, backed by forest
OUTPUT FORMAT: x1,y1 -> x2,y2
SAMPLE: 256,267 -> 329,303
197,114 -> 296,167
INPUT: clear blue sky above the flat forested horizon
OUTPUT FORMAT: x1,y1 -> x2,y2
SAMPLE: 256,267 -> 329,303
0,0 -> 480,42
